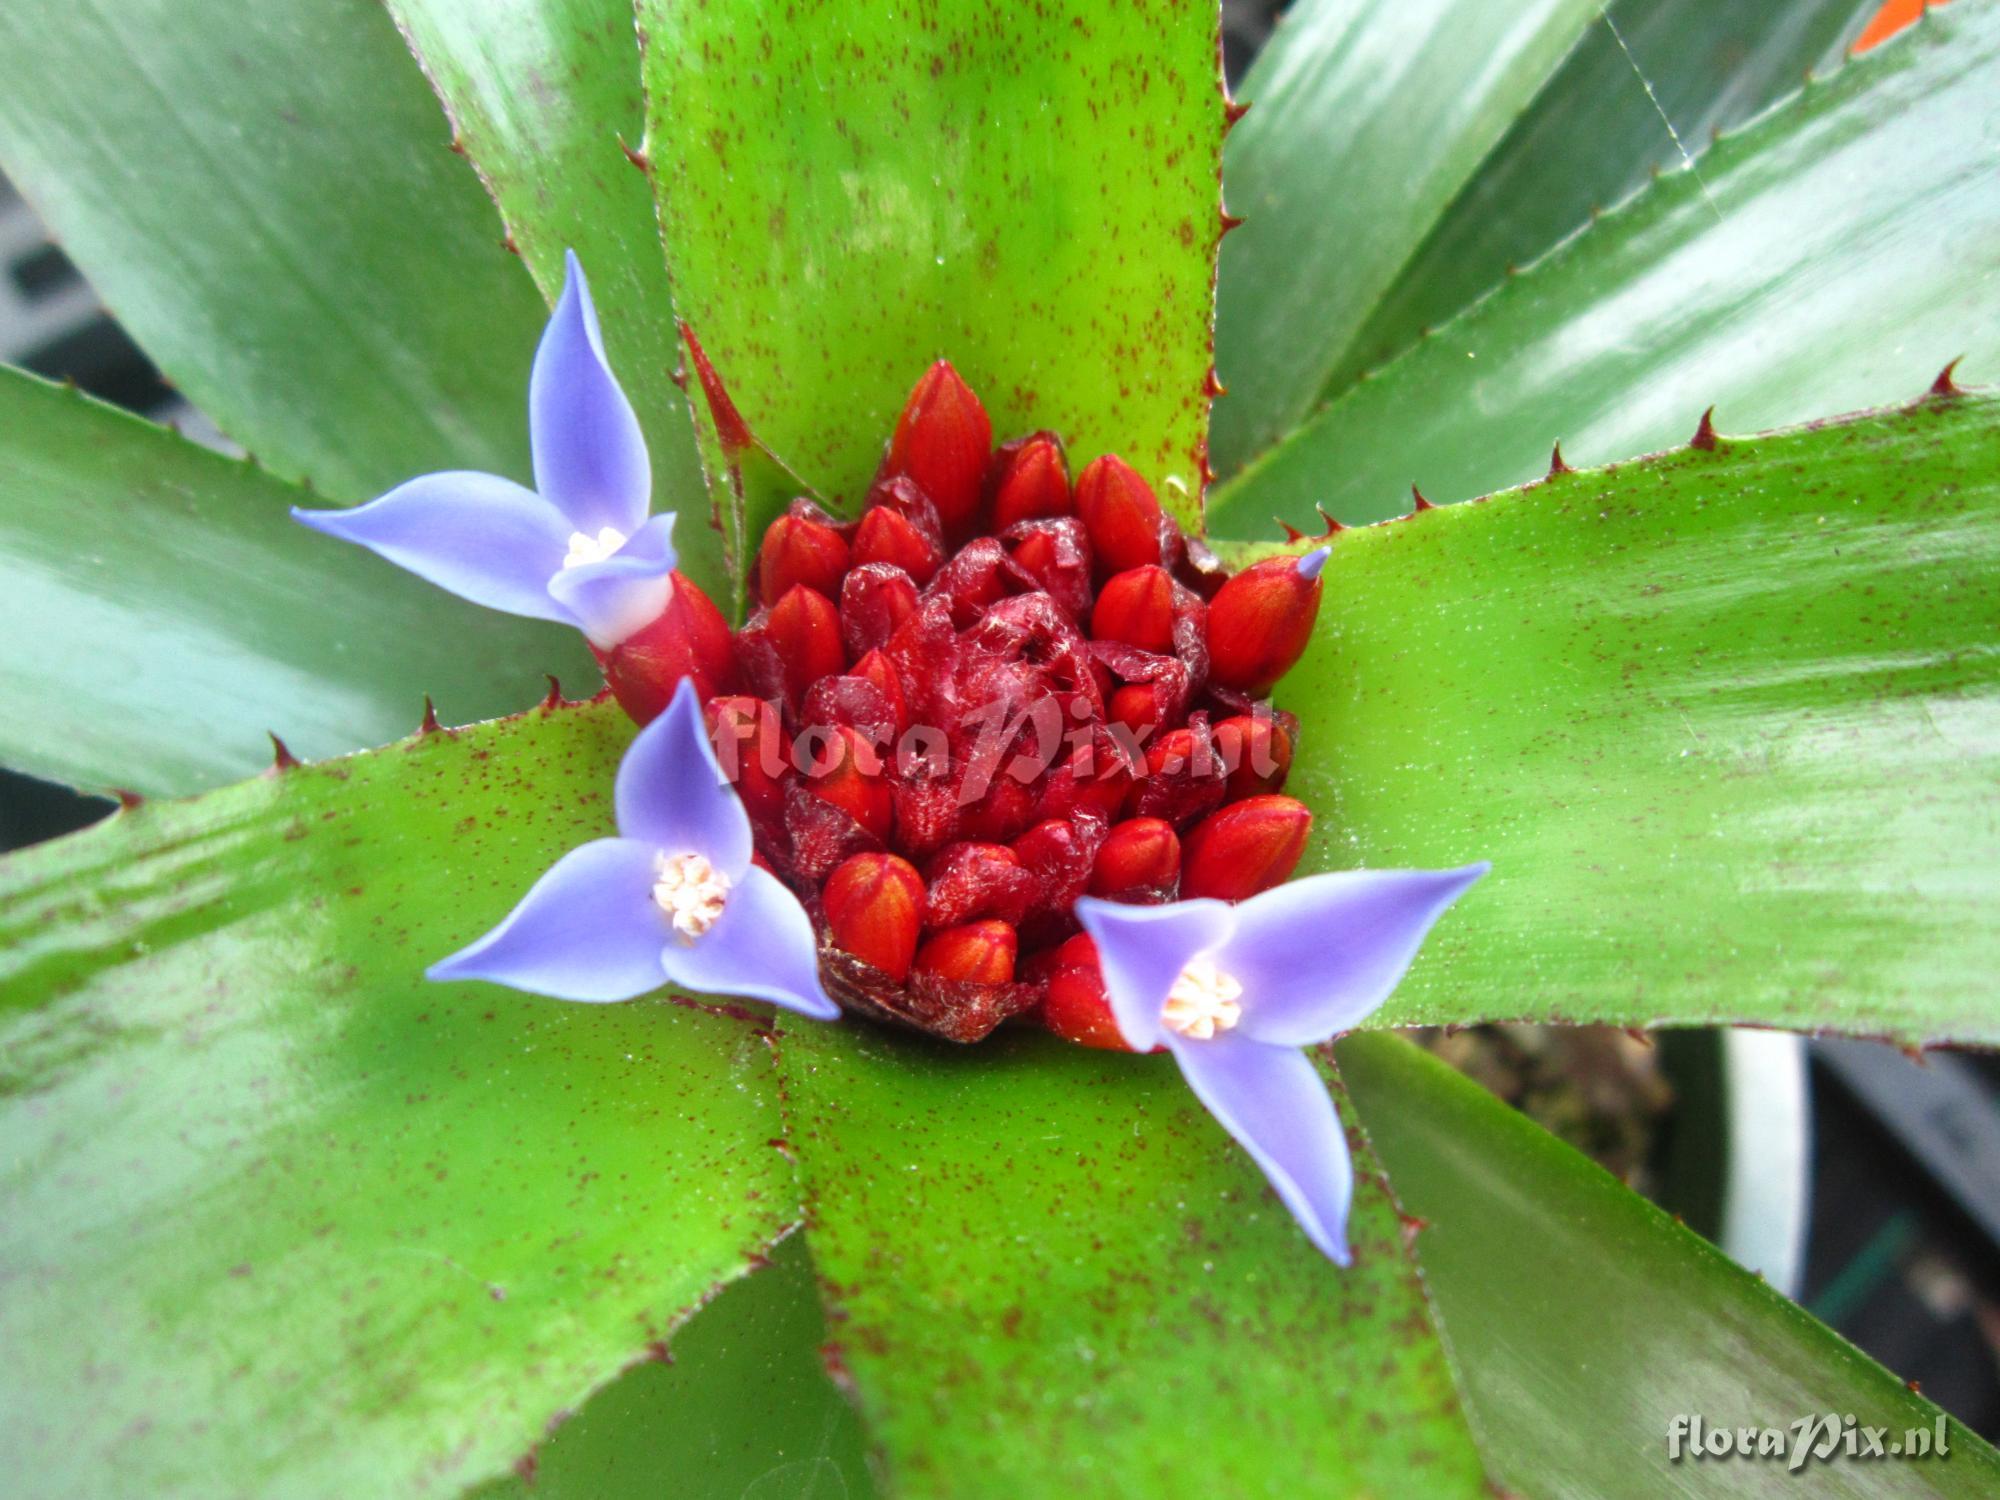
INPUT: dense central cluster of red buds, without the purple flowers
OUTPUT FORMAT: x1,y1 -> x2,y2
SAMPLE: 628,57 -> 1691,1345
606,360 -> 1320,1048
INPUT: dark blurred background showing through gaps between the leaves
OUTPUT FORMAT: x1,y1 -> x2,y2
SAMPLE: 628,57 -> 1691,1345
0,0 -> 2000,1440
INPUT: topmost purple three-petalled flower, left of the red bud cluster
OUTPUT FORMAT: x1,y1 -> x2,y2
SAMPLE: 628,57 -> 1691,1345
292,252 -> 674,650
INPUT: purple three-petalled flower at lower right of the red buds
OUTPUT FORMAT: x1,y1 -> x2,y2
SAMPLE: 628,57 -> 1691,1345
1076,864 -> 1490,1266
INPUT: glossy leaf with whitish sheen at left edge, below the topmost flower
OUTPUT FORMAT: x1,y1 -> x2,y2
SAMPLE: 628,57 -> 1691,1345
0,368 -> 596,794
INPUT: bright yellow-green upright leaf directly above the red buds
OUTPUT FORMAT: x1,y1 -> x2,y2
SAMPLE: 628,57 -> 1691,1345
640,0 -> 1224,528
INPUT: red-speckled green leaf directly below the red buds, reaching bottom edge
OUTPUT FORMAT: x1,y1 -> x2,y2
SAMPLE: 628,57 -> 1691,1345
778,1026 -> 1488,1498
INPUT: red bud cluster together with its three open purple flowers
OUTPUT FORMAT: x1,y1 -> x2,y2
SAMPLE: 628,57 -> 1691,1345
294,256 -> 1486,1264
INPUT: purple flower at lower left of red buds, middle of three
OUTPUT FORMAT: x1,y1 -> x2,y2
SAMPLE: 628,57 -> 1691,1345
428,678 -> 840,1020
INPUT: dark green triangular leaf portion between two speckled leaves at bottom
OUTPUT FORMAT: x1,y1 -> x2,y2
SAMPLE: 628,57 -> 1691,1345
478,1234 -> 874,1500
